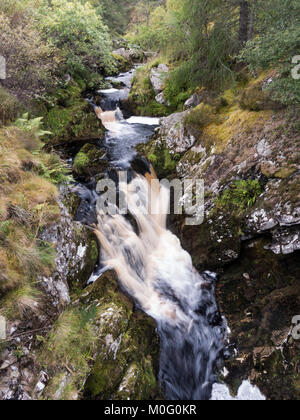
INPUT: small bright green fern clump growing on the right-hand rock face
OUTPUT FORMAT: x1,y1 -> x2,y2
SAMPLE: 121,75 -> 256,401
215,180 -> 262,211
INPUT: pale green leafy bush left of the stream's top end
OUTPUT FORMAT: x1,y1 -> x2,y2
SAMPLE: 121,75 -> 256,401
39,0 -> 116,77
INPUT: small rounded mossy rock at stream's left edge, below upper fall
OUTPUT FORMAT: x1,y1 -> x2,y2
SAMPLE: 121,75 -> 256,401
72,144 -> 108,179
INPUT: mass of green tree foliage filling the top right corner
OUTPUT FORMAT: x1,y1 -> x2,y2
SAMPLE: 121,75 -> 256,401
128,0 -> 300,105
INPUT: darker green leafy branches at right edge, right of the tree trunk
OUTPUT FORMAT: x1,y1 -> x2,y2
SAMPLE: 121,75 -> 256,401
238,0 -> 300,105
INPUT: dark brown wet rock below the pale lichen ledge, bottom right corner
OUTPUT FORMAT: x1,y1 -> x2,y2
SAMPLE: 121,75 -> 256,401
217,239 -> 300,400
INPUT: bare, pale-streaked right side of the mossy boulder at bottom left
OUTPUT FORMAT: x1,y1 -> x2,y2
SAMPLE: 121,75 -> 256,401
85,274 -> 159,399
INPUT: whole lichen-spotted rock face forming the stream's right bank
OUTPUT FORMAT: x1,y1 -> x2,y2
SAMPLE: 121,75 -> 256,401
144,84 -> 300,399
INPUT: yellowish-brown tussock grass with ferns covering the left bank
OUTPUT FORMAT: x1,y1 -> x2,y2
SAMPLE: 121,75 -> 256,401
0,115 -> 68,319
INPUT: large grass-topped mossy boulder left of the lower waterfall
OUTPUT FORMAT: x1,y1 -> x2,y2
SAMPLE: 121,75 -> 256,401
39,271 -> 159,400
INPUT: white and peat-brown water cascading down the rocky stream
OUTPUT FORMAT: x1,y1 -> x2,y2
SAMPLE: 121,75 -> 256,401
79,69 -> 226,400
